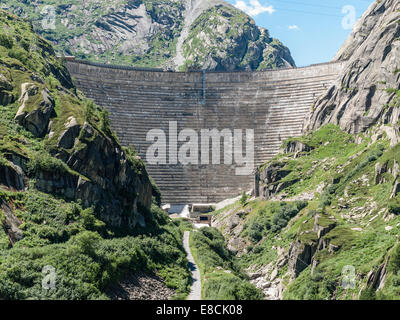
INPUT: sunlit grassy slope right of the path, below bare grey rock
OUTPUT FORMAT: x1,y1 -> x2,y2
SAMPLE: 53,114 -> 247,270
217,125 -> 400,299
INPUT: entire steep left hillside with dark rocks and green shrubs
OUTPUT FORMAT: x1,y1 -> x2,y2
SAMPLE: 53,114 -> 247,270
0,10 -> 190,300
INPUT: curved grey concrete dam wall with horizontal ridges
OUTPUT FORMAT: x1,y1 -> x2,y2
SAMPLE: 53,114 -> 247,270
66,60 -> 343,204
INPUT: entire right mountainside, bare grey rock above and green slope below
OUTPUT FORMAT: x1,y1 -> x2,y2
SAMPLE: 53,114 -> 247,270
214,0 -> 400,300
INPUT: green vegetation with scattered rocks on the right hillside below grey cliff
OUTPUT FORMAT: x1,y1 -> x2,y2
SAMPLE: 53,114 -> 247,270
216,125 -> 400,299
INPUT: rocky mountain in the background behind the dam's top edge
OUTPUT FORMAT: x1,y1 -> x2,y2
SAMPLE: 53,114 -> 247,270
0,0 -> 295,70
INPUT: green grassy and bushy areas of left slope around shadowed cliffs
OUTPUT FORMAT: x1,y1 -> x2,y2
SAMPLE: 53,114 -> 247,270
0,11 -> 190,299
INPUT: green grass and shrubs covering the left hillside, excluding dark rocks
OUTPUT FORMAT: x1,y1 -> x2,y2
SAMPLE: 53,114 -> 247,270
0,10 -> 190,299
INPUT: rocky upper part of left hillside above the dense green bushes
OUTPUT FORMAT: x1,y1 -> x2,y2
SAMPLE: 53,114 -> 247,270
0,10 -> 154,230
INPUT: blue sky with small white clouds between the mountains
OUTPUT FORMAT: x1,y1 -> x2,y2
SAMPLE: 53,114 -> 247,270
228,0 -> 374,67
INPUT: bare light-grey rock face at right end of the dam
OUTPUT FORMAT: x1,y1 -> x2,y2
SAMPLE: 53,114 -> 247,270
305,0 -> 400,133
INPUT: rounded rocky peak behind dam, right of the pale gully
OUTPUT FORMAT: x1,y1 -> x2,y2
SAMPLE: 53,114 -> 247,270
182,4 -> 295,70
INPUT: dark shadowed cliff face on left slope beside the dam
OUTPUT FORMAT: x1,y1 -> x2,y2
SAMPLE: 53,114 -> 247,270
62,123 -> 152,227
